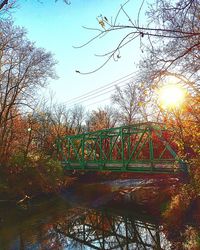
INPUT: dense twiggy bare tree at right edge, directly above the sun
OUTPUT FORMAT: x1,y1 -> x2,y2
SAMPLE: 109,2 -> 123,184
137,0 -> 200,94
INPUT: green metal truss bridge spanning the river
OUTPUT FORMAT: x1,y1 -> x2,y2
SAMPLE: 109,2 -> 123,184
56,123 -> 187,173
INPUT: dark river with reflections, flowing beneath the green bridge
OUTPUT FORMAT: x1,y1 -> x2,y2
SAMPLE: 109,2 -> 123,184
0,180 -> 198,250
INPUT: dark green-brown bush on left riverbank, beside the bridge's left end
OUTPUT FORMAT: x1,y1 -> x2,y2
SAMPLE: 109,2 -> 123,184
0,152 -> 72,198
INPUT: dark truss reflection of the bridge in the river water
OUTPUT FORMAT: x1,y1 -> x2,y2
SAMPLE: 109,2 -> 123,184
53,209 -> 170,250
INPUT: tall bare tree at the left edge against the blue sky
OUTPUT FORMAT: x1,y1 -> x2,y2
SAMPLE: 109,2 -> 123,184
0,21 -> 56,163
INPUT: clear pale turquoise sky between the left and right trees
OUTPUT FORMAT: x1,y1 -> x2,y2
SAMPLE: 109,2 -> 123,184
13,0 -> 147,109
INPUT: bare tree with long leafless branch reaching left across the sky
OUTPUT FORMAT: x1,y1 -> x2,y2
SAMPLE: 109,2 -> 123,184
76,0 -> 200,77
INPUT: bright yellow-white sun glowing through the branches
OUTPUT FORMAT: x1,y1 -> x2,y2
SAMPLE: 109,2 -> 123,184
158,84 -> 185,109
